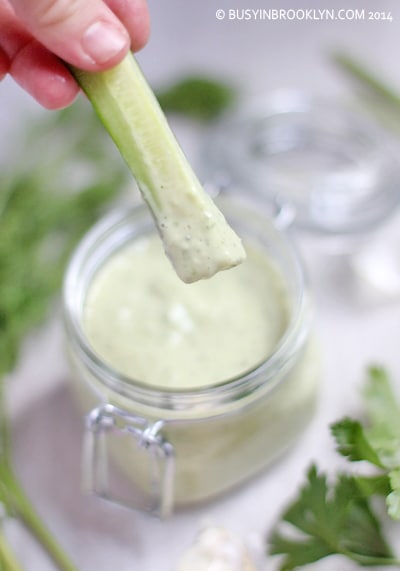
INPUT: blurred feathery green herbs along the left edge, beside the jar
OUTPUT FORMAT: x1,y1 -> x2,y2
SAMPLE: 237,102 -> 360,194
0,102 -> 126,377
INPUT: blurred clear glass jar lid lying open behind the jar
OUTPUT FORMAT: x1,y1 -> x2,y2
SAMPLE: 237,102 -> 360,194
202,91 -> 400,239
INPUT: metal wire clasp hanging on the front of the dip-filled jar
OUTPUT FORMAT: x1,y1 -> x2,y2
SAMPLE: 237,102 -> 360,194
83,404 -> 175,518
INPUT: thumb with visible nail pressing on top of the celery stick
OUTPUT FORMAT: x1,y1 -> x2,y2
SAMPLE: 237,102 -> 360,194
10,0 -> 130,71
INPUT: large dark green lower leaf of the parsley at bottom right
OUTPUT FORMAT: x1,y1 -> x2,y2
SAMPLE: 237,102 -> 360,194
269,466 -> 399,571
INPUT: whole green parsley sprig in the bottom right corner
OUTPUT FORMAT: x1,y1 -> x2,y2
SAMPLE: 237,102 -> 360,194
268,367 -> 400,571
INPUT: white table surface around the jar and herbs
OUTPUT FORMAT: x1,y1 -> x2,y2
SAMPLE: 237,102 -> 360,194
0,0 -> 400,571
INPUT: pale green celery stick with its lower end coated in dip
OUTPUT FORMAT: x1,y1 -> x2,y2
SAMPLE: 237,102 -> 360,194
68,54 -> 245,282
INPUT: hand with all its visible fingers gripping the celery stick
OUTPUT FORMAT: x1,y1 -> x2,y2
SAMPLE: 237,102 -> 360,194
0,0 -> 149,109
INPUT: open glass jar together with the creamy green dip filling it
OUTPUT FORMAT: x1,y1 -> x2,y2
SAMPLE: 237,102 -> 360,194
64,197 -> 318,516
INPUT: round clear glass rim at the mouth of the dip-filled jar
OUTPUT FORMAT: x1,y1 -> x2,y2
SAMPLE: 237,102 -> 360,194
63,197 -> 309,410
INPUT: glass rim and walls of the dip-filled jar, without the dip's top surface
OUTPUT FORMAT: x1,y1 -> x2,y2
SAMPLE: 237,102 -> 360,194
64,196 -> 318,517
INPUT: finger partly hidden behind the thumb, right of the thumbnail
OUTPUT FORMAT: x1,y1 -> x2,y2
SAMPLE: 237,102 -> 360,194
106,0 -> 150,52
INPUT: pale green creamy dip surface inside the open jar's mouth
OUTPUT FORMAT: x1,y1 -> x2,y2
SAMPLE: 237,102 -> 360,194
83,235 -> 290,389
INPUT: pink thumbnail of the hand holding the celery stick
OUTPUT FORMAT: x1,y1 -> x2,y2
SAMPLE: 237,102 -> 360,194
81,22 -> 129,64
